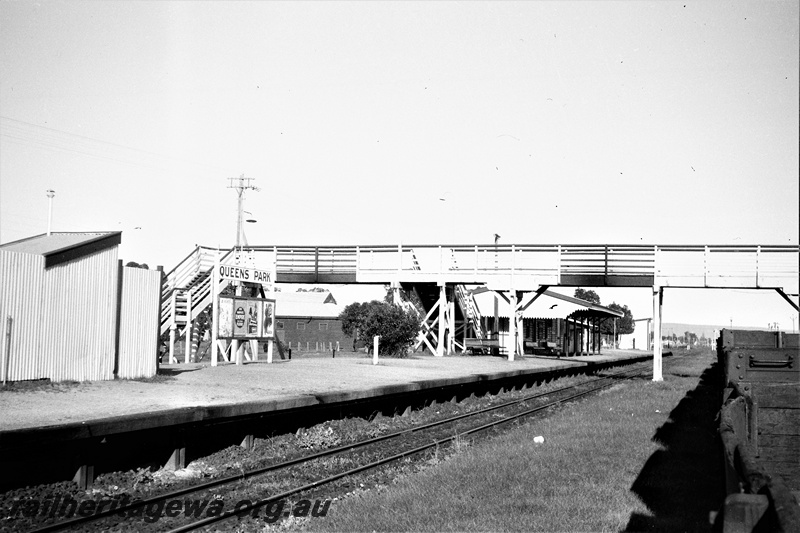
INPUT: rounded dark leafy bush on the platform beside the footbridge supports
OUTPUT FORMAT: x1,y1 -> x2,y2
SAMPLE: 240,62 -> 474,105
339,300 -> 420,357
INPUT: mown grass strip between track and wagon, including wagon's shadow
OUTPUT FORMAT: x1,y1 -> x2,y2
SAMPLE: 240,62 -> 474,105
308,351 -> 724,531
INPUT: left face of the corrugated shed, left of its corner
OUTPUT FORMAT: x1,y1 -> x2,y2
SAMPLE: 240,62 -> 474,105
0,251 -> 47,381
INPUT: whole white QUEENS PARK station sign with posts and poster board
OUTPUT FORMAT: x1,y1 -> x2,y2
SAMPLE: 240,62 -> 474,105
211,254 -> 275,366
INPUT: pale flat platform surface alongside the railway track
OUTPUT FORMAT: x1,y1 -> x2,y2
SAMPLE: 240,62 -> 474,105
0,350 -> 652,431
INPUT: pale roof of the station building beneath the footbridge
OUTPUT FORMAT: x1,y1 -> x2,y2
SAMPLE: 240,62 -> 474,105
474,290 -> 623,318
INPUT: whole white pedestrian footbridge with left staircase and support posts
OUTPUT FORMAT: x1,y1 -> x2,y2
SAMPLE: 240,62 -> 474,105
161,244 -> 800,378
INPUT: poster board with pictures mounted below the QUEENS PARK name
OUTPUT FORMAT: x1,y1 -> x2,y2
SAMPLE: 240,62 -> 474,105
217,296 -> 275,340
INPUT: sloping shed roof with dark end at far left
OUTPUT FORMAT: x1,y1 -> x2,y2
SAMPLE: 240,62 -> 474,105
0,231 -> 122,267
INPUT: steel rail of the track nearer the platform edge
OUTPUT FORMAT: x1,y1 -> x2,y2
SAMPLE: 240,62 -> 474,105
30,361 -> 646,533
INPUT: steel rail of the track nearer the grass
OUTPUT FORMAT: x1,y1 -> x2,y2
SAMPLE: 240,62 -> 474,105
169,358 -> 668,533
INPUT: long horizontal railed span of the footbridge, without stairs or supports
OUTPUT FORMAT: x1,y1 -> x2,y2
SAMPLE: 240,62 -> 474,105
239,244 -> 800,293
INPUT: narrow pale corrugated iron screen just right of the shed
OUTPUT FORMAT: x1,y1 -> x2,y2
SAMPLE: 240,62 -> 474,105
117,267 -> 161,378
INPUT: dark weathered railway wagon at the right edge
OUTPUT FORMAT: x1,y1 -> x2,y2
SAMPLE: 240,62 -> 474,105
717,329 -> 800,532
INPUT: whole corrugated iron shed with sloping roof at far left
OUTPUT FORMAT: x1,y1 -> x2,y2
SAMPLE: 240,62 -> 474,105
0,232 -> 121,381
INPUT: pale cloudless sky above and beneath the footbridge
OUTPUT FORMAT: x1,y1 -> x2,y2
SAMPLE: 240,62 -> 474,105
0,0 -> 800,327
